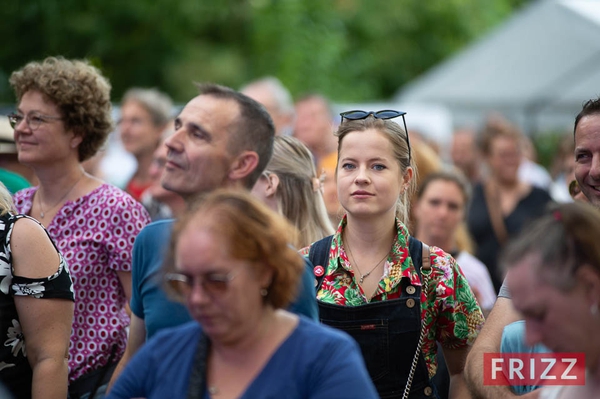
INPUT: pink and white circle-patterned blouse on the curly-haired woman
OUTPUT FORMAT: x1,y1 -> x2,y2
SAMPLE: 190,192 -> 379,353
14,184 -> 150,382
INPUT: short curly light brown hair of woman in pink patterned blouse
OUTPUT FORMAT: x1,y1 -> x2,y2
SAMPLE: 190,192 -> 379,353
9,57 -> 113,162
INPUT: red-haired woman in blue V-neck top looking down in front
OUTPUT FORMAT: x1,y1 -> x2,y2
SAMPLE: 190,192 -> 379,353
109,190 -> 377,399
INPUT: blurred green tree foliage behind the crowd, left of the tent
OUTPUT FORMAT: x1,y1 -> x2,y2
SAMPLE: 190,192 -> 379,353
0,0 -> 527,103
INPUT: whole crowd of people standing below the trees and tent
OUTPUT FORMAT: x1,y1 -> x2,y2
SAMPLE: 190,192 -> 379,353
0,57 -> 600,399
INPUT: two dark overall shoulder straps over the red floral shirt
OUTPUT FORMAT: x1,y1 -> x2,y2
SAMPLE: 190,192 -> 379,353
308,235 -> 431,289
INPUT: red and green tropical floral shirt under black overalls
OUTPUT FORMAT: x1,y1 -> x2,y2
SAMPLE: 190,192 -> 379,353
300,216 -> 484,377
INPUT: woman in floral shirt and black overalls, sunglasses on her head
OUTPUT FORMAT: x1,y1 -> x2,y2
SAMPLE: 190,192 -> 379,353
302,111 -> 483,399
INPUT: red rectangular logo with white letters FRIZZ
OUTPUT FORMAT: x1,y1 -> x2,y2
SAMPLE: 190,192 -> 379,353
483,353 -> 585,385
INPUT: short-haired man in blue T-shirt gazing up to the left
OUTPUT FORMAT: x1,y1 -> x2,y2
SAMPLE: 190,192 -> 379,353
109,84 -> 317,386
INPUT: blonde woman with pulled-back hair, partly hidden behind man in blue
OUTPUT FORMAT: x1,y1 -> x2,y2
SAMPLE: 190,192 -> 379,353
252,136 -> 334,248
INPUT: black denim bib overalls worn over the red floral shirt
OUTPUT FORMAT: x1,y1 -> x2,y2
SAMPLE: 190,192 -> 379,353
309,237 -> 437,399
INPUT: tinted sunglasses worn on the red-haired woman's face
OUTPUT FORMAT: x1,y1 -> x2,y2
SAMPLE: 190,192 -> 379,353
165,269 -> 240,298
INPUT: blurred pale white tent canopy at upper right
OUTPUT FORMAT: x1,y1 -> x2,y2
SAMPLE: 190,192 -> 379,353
395,0 -> 600,131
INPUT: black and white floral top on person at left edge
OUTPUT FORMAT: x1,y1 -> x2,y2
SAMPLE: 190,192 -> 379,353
0,214 -> 74,397
